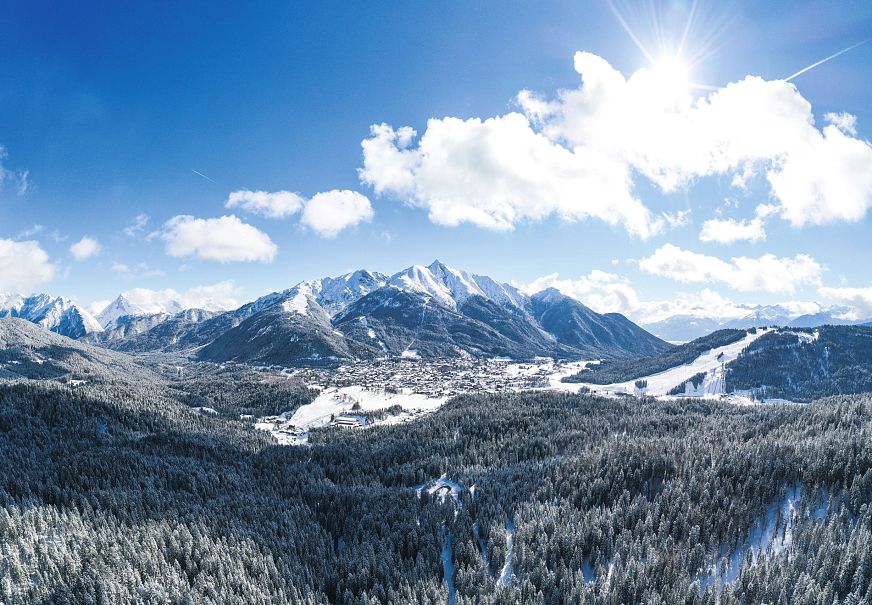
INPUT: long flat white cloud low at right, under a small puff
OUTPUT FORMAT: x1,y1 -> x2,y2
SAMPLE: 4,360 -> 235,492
639,244 -> 823,293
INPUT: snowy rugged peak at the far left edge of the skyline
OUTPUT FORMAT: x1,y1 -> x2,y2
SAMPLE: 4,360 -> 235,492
0,294 -> 103,338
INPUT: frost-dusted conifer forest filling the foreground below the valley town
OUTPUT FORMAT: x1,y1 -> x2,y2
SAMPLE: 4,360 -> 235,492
0,356 -> 872,605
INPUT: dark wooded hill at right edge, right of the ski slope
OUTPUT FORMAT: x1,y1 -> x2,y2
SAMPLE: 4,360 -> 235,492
726,326 -> 872,401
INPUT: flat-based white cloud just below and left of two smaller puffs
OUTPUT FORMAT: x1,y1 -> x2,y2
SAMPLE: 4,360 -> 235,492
159,214 -> 278,263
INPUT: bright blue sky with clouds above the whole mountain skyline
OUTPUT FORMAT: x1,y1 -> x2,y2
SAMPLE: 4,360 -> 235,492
0,0 -> 872,317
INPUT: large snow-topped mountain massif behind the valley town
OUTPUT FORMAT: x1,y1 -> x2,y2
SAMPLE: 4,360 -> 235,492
25,261 -> 671,365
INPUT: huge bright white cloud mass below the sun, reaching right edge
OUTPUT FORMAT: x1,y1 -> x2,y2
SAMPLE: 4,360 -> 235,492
360,52 -> 872,237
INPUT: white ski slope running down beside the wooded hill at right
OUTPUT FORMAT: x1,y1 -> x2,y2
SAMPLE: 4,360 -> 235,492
560,329 -> 772,397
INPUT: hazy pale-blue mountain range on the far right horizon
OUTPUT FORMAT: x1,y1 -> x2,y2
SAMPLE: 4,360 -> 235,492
642,305 -> 866,342
